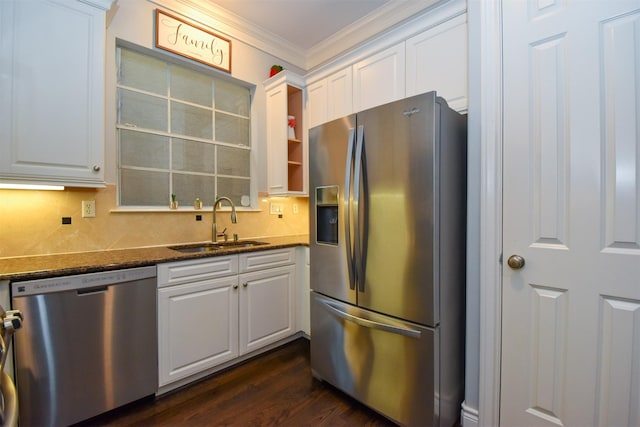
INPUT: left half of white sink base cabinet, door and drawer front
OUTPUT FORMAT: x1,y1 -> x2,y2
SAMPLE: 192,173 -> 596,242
158,255 -> 238,387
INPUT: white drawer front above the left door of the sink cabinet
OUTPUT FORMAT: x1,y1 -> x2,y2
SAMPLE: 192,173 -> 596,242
158,255 -> 238,288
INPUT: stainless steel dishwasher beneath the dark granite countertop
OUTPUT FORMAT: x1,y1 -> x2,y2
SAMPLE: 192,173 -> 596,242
11,266 -> 158,426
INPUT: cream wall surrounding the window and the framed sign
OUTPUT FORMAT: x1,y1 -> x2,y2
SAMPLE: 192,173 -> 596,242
105,0 -> 302,191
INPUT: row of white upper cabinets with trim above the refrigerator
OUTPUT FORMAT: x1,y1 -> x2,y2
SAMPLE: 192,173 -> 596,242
306,0 -> 468,122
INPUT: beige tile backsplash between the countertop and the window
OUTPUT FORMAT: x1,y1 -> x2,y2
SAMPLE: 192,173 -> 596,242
0,185 -> 309,257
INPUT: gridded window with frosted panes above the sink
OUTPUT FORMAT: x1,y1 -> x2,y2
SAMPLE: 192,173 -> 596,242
117,47 -> 251,207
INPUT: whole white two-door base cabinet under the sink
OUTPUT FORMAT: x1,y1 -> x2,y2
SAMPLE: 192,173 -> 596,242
158,248 -> 297,388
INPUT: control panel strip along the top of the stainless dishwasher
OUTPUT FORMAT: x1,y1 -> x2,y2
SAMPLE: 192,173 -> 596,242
11,265 -> 156,298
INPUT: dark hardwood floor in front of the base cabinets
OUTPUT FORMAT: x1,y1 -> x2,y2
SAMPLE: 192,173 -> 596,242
78,338 -> 394,426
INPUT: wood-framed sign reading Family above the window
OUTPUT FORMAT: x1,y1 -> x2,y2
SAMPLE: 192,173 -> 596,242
156,9 -> 231,73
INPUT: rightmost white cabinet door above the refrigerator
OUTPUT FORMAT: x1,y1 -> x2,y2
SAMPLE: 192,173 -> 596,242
406,14 -> 468,111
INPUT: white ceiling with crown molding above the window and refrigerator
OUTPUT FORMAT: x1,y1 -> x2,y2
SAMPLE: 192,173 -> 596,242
202,0 -> 443,70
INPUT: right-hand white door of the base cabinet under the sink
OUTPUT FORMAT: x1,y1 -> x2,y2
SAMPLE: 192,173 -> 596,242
239,265 -> 296,354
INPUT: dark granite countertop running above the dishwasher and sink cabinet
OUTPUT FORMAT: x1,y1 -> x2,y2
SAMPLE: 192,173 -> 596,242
0,235 -> 309,281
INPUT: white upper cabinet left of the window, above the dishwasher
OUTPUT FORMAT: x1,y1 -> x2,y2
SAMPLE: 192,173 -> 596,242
0,0 -> 111,187
